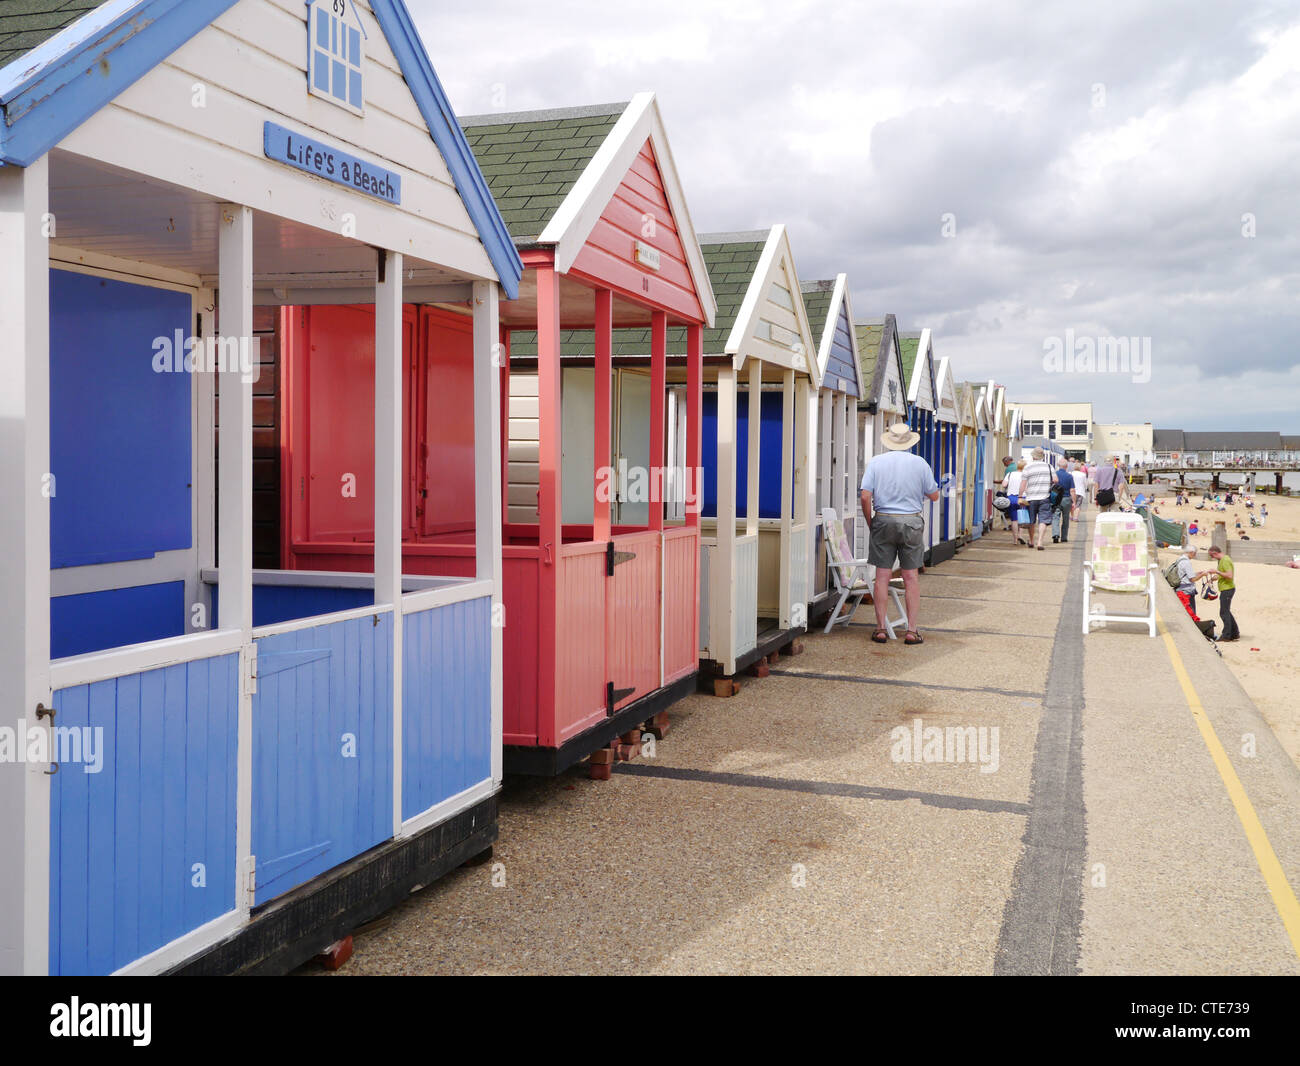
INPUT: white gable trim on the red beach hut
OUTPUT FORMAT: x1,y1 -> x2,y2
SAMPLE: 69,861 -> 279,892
537,92 -> 718,326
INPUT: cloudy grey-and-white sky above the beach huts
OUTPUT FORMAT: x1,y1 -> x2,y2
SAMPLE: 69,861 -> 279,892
410,0 -> 1300,433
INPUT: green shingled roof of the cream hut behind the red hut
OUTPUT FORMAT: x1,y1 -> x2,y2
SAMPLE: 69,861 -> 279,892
510,230 -> 769,359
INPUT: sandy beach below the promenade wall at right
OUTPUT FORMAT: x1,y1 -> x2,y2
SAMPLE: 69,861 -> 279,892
1141,486 -> 1300,766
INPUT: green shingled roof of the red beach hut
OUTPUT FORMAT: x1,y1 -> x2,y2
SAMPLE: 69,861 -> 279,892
460,103 -> 628,246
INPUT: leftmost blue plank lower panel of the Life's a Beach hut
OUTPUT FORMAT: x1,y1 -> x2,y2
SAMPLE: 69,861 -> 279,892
49,655 -> 239,975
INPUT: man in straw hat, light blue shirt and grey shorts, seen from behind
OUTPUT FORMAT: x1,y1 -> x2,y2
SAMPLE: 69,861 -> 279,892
862,423 -> 939,645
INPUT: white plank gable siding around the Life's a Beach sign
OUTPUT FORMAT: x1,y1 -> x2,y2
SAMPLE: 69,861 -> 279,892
55,0 -> 495,277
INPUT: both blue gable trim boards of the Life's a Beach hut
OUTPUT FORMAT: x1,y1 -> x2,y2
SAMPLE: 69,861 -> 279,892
0,0 -> 524,299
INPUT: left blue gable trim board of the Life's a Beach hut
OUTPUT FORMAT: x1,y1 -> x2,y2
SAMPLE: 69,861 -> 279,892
0,0 -> 238,166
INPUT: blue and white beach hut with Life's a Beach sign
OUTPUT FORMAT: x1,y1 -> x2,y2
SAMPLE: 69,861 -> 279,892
0,0 -> 523,974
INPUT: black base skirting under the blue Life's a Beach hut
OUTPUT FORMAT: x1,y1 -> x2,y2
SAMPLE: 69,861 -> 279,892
168,796 -> 497,976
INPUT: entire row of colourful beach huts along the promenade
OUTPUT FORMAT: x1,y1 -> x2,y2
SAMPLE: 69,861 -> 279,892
0,0 -> 1015,974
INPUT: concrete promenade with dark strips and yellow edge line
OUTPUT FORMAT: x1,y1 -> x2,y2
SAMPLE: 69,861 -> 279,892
312,514 -> 1300,974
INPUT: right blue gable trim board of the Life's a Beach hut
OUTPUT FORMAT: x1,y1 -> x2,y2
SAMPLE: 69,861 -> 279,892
371,0 -> 524,300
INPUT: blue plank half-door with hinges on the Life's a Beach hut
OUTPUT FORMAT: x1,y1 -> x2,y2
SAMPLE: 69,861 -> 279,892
252,612 -> 393,904
